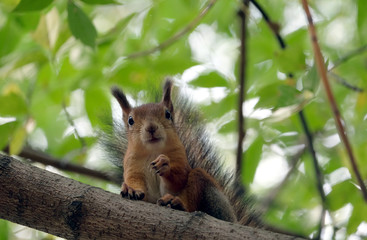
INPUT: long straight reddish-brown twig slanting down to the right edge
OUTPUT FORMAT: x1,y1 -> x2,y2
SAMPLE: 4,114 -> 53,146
302,0 -> 367,202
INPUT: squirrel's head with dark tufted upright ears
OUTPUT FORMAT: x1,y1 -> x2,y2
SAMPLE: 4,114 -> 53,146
111,79 -> 177,151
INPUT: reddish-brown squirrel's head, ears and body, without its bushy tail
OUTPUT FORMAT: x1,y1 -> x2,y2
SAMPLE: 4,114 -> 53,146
112,80 -> 236,222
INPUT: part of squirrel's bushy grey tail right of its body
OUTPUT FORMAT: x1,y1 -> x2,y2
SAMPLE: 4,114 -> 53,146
174,93 -> 262,227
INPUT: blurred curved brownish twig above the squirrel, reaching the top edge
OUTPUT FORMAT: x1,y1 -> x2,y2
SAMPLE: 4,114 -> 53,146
126,0 -> 217,59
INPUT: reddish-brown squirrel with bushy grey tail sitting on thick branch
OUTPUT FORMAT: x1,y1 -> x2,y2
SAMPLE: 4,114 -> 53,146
104,78 -> 261,227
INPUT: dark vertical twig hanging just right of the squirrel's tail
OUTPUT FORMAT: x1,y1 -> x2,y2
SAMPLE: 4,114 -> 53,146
236,0 -> 249,182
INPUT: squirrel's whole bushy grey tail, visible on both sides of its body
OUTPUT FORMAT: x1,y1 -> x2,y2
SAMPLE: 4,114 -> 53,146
100,81 -> 262,227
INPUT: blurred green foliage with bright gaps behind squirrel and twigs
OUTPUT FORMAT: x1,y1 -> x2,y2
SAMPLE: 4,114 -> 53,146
0,0 -> 367,239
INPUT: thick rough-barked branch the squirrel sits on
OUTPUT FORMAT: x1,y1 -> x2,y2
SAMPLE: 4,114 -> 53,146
0,154 -> 304,239
